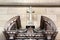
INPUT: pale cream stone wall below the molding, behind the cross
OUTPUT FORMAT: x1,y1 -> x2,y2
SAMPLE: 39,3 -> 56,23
0,7 -> 60,40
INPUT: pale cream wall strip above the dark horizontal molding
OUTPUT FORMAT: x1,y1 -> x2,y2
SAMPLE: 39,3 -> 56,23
0,0 -> 60,3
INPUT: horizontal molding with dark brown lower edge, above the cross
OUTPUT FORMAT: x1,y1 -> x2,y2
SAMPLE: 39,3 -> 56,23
0,2 -> 60,7
